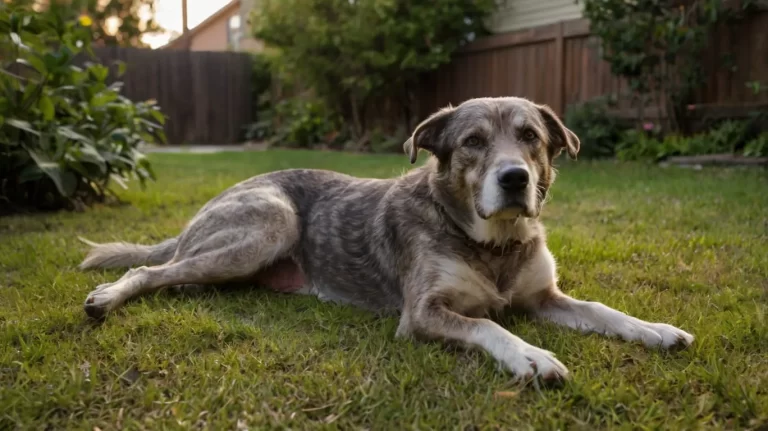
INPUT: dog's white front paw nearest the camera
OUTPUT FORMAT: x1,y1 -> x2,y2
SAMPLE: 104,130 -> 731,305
502,345 -> 569,382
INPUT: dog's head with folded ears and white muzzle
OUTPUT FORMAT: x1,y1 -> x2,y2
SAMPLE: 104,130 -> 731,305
404,97 -> 580,220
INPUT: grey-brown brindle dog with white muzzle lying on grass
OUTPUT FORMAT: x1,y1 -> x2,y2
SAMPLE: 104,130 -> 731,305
80,97 -> 694,381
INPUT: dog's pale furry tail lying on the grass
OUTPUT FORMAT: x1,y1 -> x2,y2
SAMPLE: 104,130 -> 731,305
78,237 -> 179,269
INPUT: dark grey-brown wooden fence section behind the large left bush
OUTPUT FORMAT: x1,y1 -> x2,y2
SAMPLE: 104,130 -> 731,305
85,47 -> 253,145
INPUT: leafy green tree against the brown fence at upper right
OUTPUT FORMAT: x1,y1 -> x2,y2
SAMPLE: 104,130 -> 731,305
581,0 -> 751,129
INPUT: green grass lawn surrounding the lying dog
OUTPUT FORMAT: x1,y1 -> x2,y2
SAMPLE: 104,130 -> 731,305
0,151 -> 768,430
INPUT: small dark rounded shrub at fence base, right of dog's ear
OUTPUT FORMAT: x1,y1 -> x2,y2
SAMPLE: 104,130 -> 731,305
565,98 -> 627,158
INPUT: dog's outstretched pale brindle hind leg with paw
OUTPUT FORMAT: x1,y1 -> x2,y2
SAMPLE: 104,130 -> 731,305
84,187 -> 300,318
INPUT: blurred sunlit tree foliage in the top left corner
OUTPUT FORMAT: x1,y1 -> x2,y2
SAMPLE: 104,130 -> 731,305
6,0 -> 161,47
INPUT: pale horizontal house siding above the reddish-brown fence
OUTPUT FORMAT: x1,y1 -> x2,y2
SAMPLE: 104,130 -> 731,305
488,0 -> 582,33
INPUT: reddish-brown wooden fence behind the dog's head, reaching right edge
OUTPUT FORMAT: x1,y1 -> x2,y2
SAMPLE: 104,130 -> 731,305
419,12 -> 768,118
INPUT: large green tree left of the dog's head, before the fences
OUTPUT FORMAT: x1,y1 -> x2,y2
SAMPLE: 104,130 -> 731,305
252,0 -> 495,138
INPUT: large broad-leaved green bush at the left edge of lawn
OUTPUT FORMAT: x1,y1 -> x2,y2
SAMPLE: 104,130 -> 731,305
0,6 -> 165,214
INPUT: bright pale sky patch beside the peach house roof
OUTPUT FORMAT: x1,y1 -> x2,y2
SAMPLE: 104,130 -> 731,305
142,0 -> 231,48
